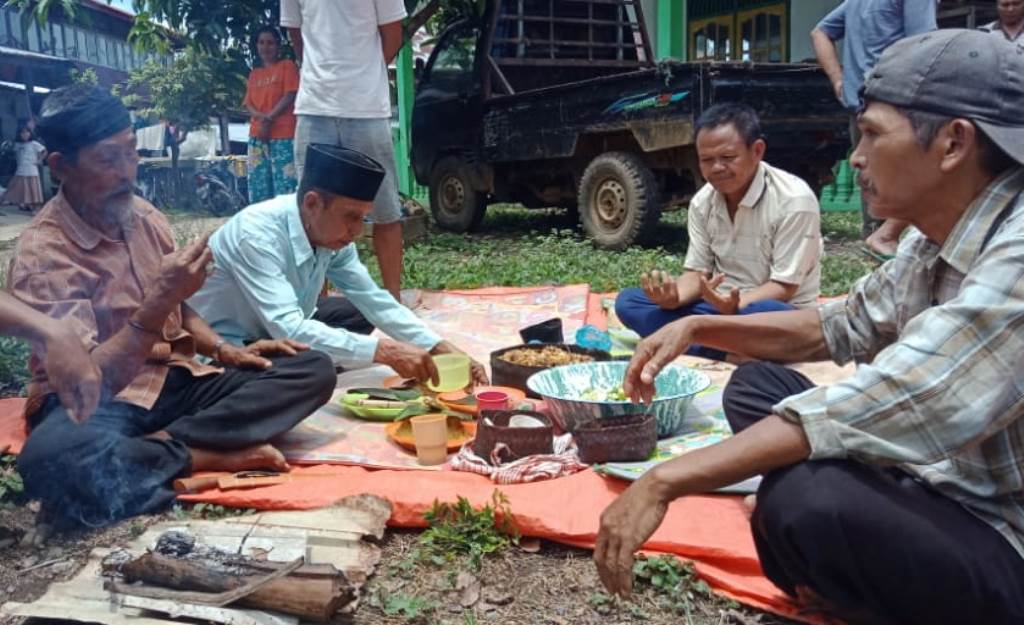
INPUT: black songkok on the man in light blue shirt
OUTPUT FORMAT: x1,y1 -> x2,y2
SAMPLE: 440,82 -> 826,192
302,143 -> 384,202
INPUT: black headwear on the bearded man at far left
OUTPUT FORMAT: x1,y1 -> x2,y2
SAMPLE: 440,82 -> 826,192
36,85 -> 131,154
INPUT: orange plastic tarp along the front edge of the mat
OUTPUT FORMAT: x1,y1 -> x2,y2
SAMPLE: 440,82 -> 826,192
182,465 -> 815,623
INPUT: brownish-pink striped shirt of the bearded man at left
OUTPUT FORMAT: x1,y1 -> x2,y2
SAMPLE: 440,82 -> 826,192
7,193 -> 220,415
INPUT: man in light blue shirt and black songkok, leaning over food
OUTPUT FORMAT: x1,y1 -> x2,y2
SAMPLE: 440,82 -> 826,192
188,143 -> 487,383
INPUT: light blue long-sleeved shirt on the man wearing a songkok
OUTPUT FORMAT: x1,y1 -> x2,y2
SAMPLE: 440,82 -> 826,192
188,194 -> 441,369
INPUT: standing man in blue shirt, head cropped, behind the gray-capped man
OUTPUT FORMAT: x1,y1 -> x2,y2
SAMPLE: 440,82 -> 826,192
811,0 -> 938,260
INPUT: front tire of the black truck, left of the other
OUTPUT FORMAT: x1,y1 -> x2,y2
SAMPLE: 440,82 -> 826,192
430,157 -> 487,233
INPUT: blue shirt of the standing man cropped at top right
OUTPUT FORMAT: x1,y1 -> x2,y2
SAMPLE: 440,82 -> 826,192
817,0 -> 938,110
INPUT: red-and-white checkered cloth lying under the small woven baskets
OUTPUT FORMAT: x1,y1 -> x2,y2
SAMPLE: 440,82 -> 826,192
449,434 -> 587,485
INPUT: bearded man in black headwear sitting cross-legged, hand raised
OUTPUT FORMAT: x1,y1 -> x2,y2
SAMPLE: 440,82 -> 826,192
7,85 -> 335,528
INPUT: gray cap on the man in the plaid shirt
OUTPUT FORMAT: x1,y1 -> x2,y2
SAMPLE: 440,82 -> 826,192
863,29 -> 1024,164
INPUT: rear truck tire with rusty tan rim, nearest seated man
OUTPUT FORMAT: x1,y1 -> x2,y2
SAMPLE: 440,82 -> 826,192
579,152 -> 662,250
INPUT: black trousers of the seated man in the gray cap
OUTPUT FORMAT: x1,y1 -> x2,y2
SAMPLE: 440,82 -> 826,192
724,363 -> 1024,625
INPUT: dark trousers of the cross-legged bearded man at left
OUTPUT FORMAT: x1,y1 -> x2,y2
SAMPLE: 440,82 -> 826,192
17,350 -> 337,530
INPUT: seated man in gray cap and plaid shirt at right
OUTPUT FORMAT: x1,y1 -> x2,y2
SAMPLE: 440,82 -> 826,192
595,30 -> 1024,625
